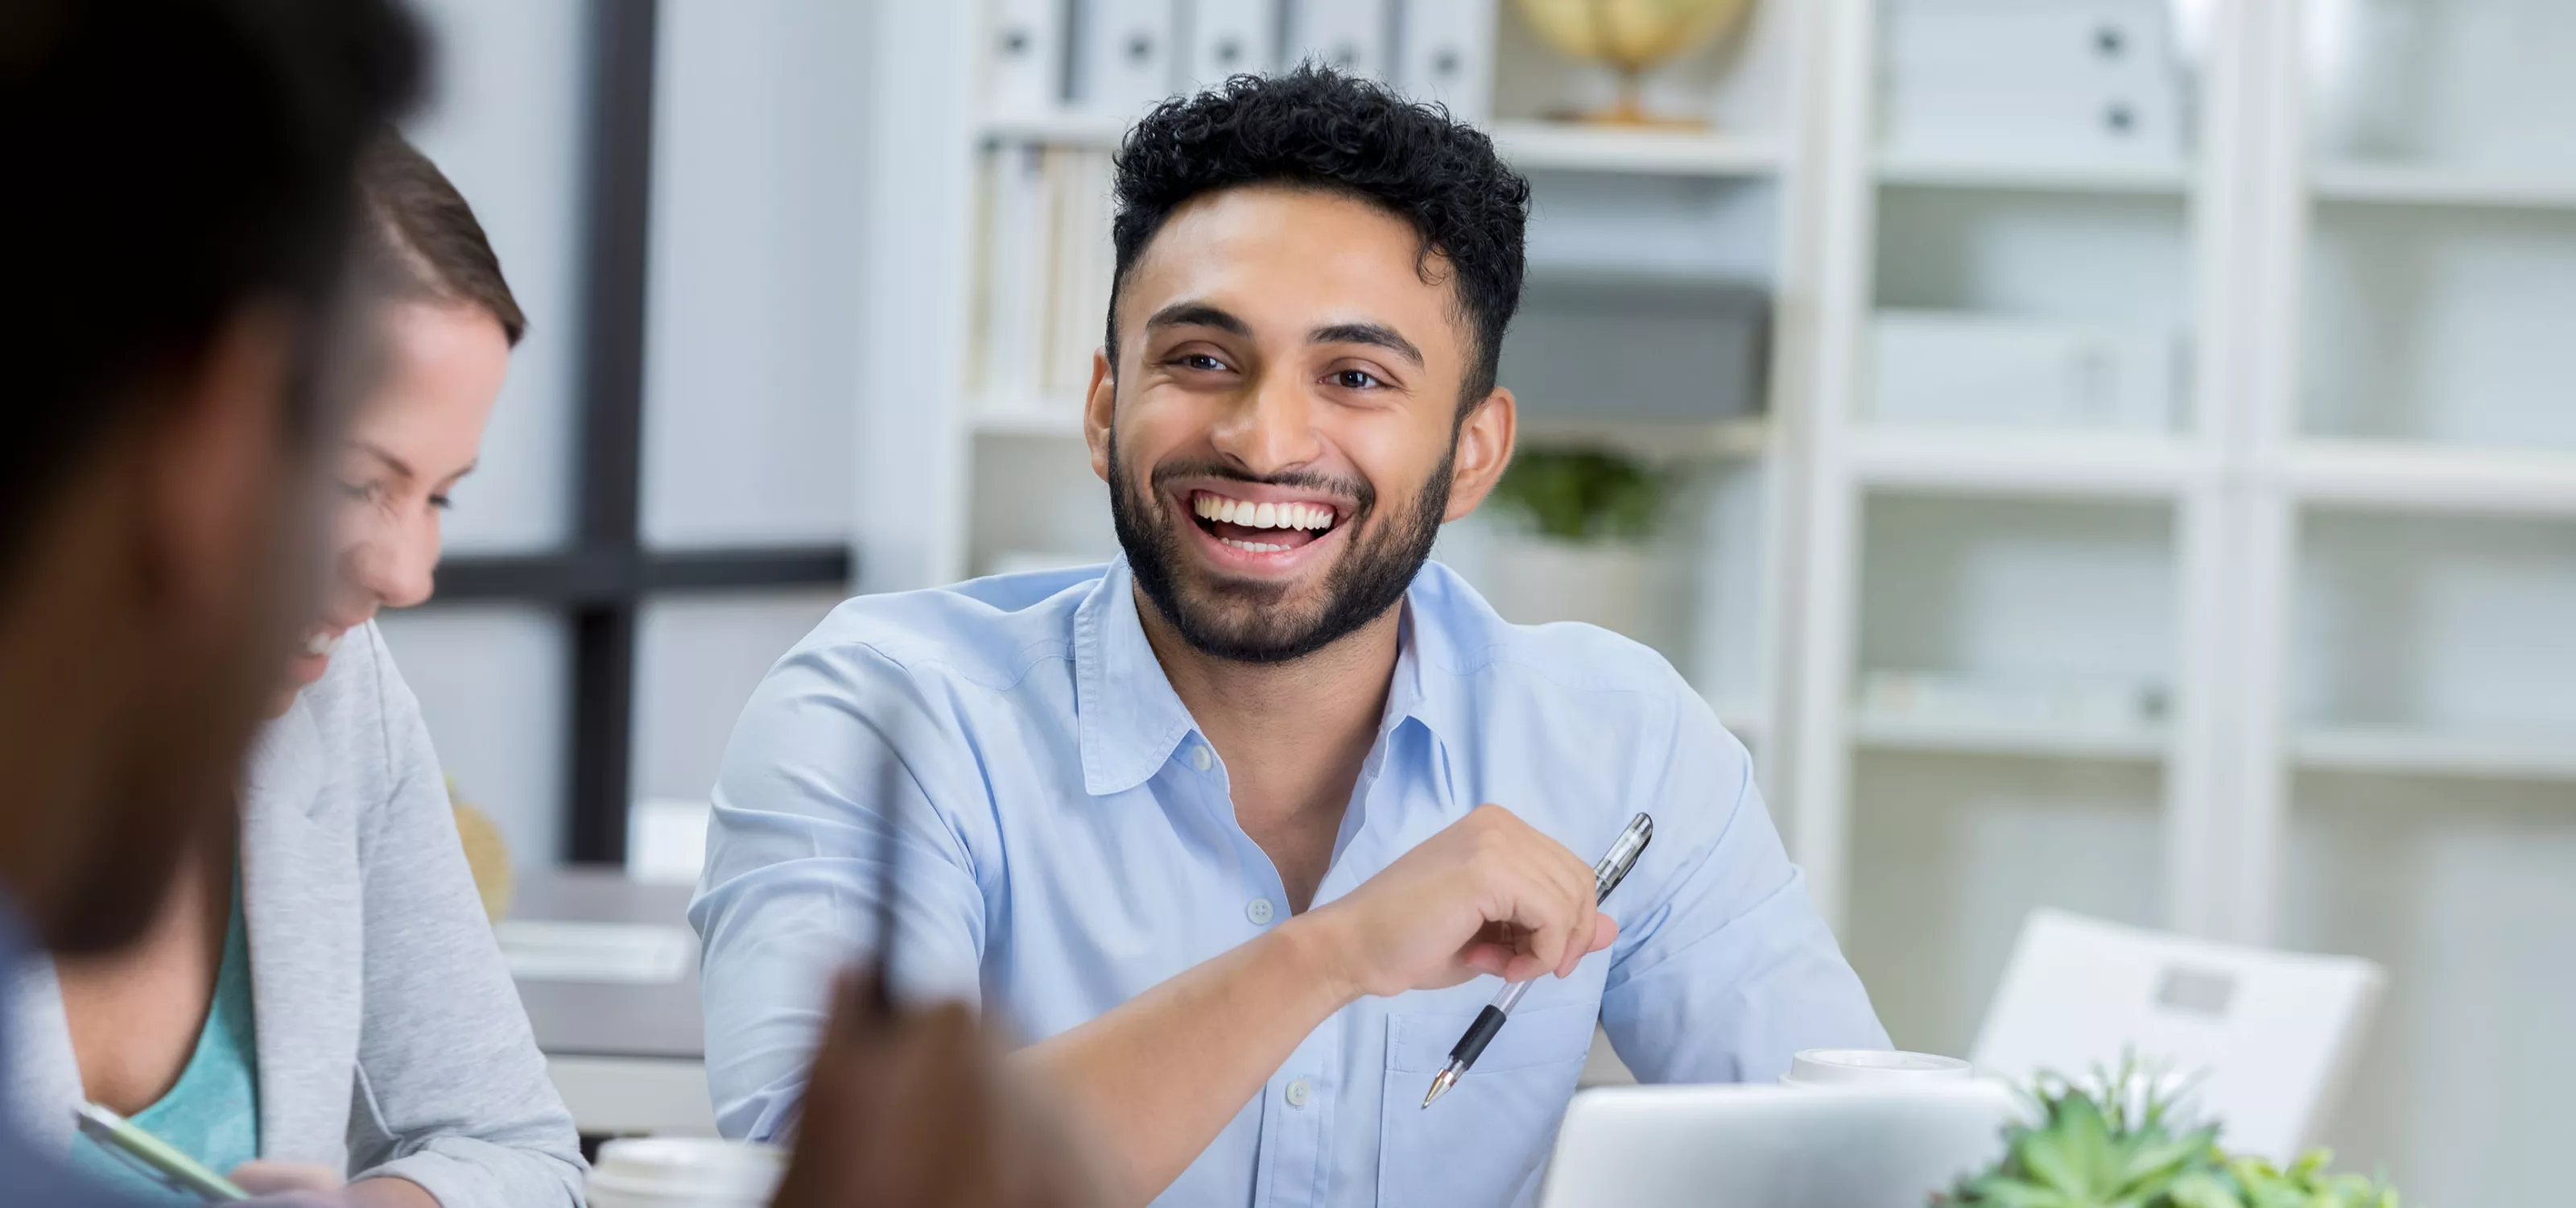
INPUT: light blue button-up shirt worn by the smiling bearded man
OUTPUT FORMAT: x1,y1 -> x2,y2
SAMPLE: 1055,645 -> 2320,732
691,564 -> 1885,1208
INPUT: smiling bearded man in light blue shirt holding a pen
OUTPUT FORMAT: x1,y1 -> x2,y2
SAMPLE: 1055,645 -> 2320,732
691,69 -> 1885,1206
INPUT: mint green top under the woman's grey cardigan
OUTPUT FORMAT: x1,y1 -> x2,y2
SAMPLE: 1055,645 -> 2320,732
72,875 -> 260,1206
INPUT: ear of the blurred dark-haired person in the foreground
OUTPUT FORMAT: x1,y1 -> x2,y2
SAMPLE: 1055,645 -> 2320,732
137,307 -> 296,615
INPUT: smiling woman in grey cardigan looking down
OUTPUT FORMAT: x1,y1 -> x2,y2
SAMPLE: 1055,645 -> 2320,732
10,134 -> 582,1208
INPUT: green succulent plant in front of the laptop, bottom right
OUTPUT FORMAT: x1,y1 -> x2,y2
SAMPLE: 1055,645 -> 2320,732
1932,1061 -> 2398,1208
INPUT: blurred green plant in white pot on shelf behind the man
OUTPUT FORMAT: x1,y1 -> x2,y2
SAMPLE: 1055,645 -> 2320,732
1486,449 -> 1670,644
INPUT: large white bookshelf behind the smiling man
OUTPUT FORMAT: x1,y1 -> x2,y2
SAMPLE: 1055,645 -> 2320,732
868,0 -> 2576,1203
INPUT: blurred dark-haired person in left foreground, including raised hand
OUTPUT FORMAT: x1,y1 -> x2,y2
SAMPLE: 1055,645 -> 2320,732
0,0 -> 1092,1208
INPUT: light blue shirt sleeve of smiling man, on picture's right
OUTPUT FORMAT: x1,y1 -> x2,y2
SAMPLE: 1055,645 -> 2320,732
1602,688 -> 1889,1082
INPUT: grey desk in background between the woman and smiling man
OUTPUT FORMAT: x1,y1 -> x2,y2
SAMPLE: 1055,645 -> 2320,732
510,868 -> 706,1061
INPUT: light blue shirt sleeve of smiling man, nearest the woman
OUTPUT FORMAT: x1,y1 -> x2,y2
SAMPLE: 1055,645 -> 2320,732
687,644 -> 984,1141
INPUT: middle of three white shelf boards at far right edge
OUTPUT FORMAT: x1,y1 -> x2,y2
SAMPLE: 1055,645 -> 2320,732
2290,441 -> 2576,515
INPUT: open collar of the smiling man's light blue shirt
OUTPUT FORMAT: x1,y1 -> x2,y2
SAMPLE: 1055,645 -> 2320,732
1074,556 -> 1484,796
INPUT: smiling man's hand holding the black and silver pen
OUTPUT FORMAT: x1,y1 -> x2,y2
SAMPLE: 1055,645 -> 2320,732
1296,806 -> 1618,997
